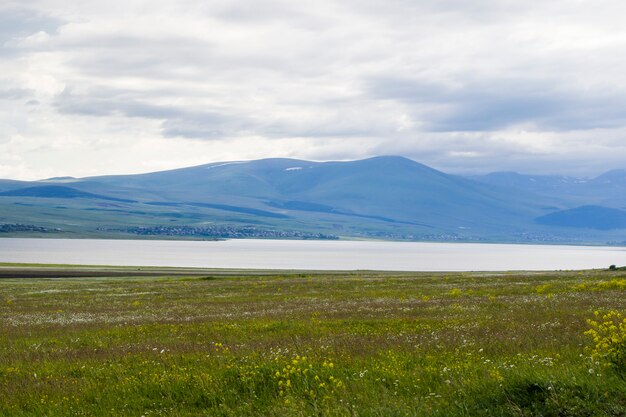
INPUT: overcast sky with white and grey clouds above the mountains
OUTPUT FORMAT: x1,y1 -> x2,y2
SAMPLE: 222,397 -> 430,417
0,0 -> 626,179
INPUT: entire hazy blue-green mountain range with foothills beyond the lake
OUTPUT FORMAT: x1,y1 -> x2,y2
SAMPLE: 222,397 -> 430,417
0,156 -> 626,244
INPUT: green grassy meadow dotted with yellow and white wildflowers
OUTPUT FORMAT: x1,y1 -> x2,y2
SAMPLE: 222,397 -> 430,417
0,266 -> 626,417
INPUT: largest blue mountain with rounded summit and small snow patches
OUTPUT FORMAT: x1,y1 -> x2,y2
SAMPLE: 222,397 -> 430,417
75,156 -> 534,228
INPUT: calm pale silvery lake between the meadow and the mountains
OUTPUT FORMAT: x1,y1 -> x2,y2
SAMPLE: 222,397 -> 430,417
0,238 -> 626,271
